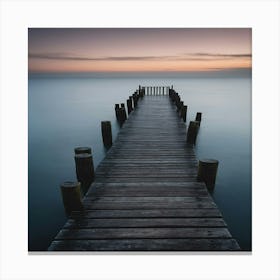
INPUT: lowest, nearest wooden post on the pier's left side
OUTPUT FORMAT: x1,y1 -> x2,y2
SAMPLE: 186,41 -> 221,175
60,182 -> 84,215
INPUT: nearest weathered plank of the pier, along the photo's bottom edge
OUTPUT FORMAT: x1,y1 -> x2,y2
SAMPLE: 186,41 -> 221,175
49,238 -> 240,251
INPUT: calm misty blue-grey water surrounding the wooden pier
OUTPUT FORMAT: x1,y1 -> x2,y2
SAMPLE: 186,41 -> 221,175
28,71 -> 251,251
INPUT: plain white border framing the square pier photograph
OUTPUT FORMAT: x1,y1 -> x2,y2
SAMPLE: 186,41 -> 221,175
0,0 -> 280,280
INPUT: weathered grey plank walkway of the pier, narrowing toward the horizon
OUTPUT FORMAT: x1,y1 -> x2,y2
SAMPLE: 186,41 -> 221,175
49,87 -> 240,251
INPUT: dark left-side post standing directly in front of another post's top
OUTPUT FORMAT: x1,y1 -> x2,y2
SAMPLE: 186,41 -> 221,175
75,154 -> 94,193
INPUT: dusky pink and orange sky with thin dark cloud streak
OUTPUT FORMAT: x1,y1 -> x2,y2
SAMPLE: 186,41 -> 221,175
28,28 -> 252,73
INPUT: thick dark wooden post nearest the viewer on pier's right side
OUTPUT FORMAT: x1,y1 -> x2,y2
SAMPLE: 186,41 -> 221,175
197,159 -> 219,189
